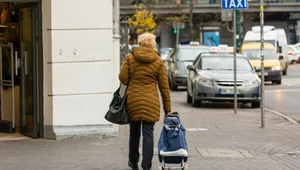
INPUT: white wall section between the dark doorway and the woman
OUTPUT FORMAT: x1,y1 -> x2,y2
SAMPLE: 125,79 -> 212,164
42,0 -> 119,138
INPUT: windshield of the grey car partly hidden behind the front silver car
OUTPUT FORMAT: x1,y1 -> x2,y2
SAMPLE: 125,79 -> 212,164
177,48 -> 209,61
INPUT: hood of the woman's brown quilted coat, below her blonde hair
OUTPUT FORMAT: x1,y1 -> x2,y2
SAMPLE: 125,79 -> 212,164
133,47 -> 159,63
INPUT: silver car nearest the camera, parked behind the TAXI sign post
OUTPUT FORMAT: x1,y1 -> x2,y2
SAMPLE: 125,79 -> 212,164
187,53 -> 261,108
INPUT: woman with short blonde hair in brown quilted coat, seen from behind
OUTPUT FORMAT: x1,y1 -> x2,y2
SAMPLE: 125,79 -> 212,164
119,33 -> 171,170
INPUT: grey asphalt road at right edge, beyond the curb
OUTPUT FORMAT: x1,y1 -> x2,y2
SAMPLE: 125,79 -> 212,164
265,64 -> 300,122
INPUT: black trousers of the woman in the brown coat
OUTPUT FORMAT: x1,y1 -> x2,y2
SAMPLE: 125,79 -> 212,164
129,121 -> 154,169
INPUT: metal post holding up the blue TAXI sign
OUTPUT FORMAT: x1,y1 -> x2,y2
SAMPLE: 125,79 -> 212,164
233,11 -> 237,113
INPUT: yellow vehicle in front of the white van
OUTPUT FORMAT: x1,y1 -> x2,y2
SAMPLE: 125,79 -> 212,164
240,42 -> 283,84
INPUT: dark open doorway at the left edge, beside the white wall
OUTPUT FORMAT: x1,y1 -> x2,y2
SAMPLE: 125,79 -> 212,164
0,2 -> 43,138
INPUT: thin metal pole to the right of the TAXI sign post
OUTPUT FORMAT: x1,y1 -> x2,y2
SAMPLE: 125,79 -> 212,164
260,0 -> 265,128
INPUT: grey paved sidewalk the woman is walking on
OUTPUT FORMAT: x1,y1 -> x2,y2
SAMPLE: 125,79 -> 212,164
0,98 -> 300,170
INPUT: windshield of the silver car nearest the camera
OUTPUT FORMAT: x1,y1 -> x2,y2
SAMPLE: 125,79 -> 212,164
198,56 -> 252,71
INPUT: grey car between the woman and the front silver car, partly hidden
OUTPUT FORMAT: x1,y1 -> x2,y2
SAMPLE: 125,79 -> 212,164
165,42 -> 209,90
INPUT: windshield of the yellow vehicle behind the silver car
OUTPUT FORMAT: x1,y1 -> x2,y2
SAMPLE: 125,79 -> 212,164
243,50 -> 276,60
